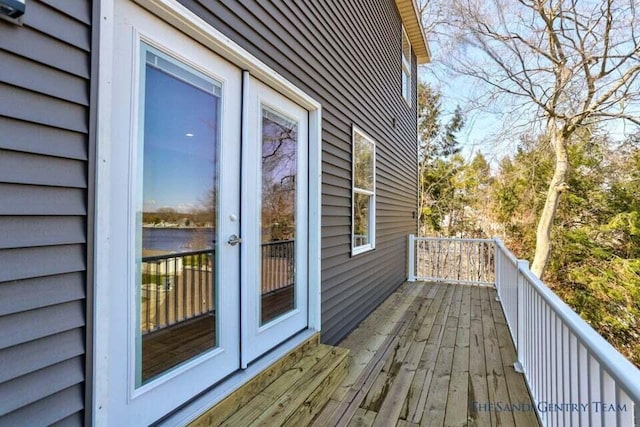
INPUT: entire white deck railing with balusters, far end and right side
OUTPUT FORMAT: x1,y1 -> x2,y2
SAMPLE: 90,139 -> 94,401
408,235 -> 640,427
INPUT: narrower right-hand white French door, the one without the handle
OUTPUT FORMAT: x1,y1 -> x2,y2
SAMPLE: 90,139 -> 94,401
241,73 -> 308,367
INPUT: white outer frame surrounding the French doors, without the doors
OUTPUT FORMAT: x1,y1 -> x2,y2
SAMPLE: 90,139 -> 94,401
94,0 -> 322,425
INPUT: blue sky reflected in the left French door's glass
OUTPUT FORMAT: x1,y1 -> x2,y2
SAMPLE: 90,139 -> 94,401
143,66 -> 220,212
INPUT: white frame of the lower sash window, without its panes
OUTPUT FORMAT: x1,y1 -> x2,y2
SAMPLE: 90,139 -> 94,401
351,126 -> 376,256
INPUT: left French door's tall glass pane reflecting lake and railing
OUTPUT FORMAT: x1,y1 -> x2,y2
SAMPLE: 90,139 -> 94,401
136,45 -> 220,385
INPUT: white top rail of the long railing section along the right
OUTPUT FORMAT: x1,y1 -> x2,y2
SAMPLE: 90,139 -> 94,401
519,267 -> 640,402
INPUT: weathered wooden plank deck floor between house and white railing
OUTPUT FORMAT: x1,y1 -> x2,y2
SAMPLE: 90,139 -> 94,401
314,282 -> 538,426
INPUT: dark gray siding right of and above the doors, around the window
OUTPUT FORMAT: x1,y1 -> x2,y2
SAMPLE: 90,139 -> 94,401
180,0 -> 417,343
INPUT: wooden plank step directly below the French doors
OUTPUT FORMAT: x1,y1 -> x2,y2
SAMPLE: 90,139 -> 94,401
191,339 -> 349,427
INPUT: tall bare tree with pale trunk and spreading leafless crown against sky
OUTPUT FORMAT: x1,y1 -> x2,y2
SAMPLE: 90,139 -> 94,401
421,0 -> 640,275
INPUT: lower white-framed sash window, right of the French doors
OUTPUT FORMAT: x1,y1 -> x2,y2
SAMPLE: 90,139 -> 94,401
351,128 -> 376,255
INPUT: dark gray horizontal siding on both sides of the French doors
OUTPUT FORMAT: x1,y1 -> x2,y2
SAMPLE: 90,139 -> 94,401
0,0 -> 417,426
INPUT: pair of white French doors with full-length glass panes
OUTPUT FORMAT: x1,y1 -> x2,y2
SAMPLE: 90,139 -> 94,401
105,0 -> 308,423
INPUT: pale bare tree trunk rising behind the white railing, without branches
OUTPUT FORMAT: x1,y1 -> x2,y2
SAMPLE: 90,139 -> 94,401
531,129 -> 569,279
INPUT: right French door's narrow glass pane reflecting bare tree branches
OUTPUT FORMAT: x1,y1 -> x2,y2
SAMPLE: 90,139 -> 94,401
260,107 -> 298,324
